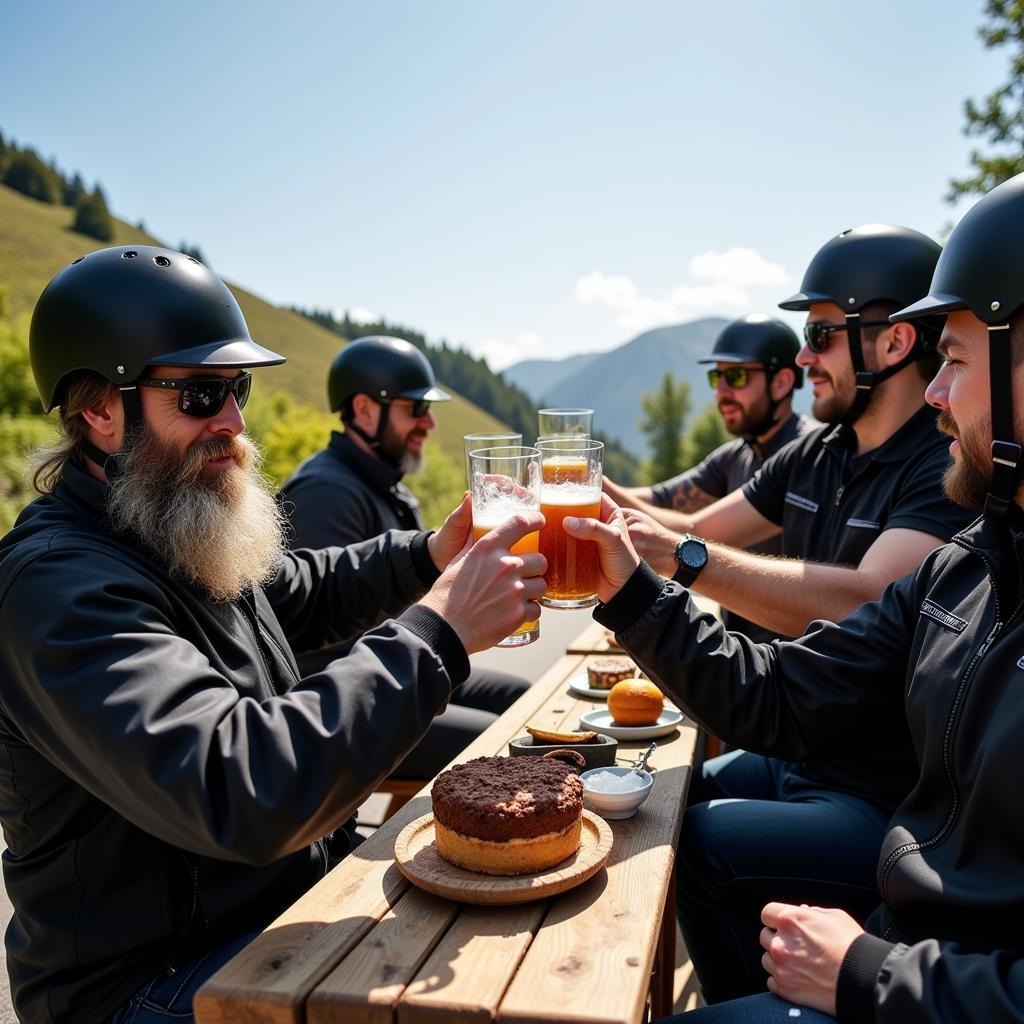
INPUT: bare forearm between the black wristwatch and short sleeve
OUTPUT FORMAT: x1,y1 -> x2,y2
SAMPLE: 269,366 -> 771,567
692,544 -> 888,637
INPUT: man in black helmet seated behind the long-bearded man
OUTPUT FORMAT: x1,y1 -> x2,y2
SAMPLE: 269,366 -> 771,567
281,335 -> 529,778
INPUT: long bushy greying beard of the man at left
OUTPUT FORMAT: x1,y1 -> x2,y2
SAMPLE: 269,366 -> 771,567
108,430 -> 285,601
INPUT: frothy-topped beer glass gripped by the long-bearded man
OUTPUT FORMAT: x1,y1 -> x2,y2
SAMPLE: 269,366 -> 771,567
469,445 -> 541,647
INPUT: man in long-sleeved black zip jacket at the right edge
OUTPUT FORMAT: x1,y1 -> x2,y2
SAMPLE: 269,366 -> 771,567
567,169 -> 1024,1024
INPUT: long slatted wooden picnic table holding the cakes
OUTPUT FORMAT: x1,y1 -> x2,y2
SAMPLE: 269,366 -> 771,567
195,622 -> 696,1024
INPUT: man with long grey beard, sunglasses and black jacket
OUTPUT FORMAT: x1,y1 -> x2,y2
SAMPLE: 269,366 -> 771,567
0,246 -> 544,1024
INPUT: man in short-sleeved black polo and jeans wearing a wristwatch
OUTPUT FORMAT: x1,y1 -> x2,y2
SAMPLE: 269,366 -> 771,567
610,224 -> 971,1002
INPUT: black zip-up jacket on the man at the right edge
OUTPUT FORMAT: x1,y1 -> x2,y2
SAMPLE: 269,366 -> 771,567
595,519 -> 1024,1024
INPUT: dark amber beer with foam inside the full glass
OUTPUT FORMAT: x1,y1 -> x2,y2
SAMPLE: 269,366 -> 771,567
541,483 -> 601,608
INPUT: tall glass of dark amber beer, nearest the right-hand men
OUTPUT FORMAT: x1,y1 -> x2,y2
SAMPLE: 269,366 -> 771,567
537,437 -> 604,608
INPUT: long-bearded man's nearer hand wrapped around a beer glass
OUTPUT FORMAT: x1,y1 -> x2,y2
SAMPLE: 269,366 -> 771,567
420,506 -> 548,654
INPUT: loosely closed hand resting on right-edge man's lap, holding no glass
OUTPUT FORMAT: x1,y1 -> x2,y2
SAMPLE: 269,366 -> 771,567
761,903 -> 864,1017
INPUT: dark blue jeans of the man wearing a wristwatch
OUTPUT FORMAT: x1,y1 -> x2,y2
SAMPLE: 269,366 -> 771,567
676,751 -> 888,1003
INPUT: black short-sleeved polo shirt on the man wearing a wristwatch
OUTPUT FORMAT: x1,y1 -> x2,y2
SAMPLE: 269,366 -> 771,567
743,406 -> 977,565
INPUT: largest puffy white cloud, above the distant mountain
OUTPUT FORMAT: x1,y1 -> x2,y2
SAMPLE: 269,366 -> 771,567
574,247 -> 793,331
